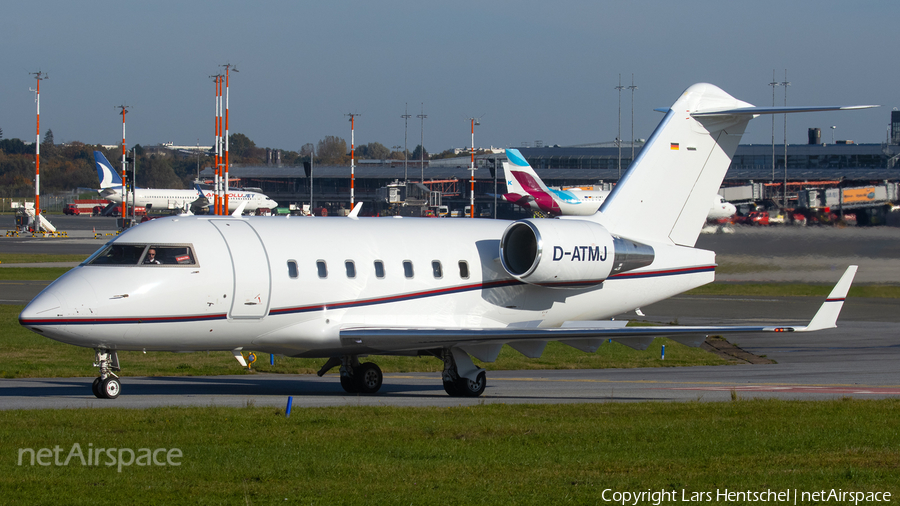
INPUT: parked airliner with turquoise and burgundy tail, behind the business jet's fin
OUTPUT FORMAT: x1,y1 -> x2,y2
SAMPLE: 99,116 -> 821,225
503,149 -> 737,220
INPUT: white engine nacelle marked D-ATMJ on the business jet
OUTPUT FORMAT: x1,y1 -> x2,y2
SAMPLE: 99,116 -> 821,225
500,219 -> 654,288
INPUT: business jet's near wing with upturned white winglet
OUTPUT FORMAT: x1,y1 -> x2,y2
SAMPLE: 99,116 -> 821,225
340,265 -> 857,356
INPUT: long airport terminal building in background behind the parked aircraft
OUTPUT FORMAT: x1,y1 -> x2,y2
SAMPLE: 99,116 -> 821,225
201,136 -> 900,215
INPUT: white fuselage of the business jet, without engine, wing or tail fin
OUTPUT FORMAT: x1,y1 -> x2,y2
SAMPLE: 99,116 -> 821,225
20,216 -> 714,357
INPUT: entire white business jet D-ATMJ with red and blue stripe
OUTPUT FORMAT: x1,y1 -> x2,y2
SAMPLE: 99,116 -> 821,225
19,84 -> 868,398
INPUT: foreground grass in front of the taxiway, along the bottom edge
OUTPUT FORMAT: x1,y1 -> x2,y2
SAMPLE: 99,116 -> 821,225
0,399 -> 900,505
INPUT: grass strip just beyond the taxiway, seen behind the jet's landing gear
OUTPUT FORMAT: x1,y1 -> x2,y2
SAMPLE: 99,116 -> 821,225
0,305 -> 729,378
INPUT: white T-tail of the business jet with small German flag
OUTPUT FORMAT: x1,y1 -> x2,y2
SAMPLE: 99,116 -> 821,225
598,83 -> 872,247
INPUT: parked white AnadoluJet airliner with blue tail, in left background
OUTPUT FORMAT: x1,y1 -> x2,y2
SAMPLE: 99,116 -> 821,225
94,151 -> 278,212
